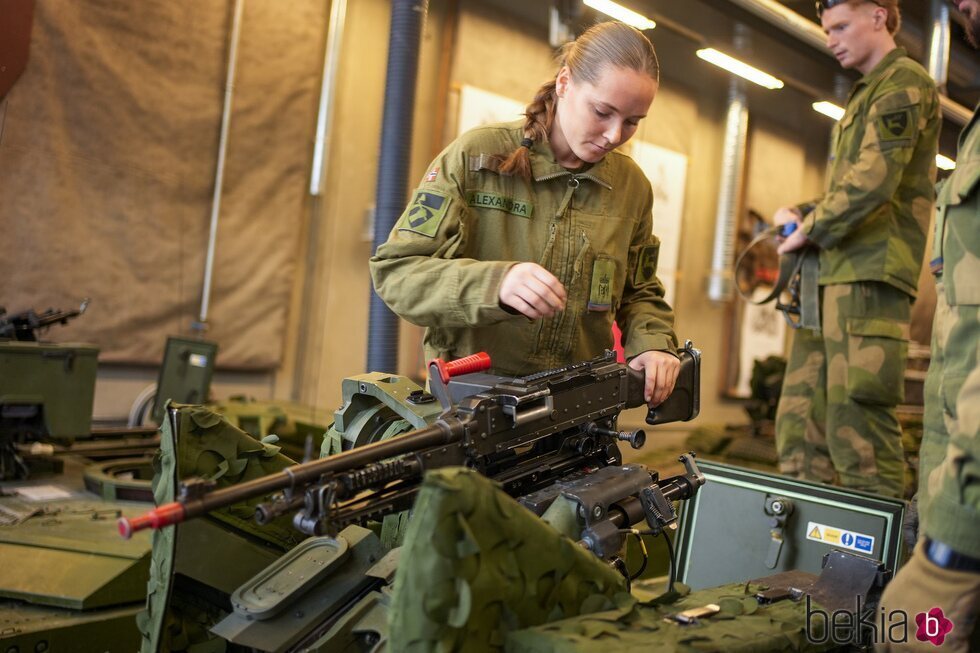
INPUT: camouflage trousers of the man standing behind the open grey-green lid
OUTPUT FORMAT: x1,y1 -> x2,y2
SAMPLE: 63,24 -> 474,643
776,281 -> 911,497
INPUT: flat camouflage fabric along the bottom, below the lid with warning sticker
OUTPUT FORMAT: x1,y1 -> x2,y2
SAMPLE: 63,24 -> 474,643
504,583 -> 834,653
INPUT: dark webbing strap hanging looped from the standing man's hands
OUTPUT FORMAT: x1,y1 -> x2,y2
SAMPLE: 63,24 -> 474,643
735,225 -> 820,331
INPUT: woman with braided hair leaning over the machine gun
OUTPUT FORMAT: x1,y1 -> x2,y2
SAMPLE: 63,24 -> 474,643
370,22 -> 680,405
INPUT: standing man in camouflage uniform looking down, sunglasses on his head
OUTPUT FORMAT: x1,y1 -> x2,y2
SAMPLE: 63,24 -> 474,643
774,0 -> 941,496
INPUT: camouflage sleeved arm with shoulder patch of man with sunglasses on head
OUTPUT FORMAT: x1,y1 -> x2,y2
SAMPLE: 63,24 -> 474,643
803,71 -> 938,249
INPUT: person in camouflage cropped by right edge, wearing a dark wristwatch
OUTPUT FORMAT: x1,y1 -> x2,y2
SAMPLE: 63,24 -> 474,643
881,0 -> 980,652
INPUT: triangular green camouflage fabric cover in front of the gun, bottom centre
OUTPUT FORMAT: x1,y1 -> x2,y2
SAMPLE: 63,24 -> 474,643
389,468 -> 631,653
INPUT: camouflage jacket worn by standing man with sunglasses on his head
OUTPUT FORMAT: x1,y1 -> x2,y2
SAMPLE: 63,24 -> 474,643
803,48 -> 942,297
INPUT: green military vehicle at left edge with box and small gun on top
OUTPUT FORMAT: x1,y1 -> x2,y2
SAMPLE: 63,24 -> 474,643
0,302 -> 158,652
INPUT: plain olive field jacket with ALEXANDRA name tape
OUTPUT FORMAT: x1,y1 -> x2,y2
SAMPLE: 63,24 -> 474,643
370,121 -> 677,375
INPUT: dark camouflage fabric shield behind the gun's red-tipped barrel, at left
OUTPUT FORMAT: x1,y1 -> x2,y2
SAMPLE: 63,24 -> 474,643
137,406 -> 304,653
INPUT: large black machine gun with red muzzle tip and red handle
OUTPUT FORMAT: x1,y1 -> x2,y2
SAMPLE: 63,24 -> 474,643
118,341 -> 703,538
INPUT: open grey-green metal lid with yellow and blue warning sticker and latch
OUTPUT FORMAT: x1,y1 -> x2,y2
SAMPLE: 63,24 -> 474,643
677,460 -> 906,589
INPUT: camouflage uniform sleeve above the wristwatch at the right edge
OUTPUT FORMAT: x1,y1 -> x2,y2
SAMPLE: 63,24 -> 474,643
919,107 -> 980,558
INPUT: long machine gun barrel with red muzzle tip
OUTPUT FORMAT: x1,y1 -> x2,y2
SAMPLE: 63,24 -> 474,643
118,419 -> 463,539
